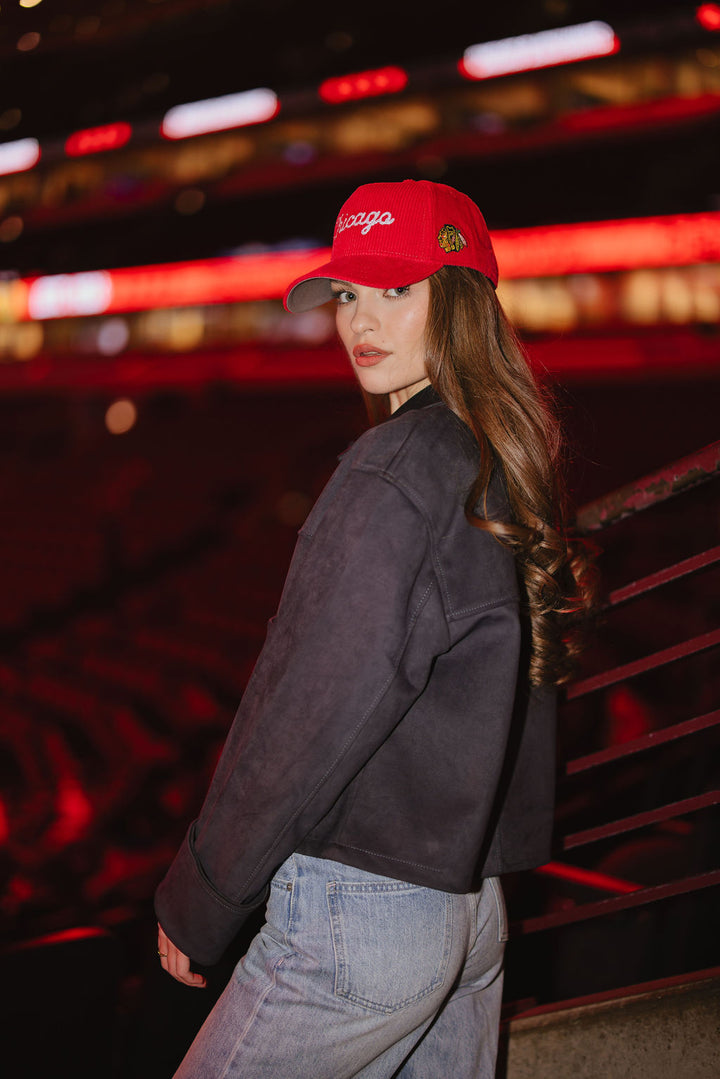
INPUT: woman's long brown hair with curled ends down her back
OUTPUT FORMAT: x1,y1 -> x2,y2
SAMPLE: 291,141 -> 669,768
426,267 -> 595,685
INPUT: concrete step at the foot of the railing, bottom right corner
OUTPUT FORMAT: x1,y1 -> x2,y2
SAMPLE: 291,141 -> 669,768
498,968 -> 720,1079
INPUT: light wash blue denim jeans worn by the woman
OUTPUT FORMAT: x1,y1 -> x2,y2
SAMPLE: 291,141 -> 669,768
175,855 -> 506,1079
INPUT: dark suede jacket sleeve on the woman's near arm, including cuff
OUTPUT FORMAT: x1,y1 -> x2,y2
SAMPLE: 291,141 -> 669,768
155,465 -> 448,964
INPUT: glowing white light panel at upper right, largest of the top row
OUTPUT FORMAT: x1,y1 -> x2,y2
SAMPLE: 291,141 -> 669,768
459,21 -> 620,79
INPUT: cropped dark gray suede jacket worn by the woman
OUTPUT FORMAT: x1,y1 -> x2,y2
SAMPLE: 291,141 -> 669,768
155,388 -> 555,964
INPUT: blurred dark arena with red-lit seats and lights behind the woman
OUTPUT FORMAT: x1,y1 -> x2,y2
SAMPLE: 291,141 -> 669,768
0,0 -> 720,1079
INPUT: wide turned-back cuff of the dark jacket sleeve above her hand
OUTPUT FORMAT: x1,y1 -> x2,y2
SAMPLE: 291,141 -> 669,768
154,822 -> 269,966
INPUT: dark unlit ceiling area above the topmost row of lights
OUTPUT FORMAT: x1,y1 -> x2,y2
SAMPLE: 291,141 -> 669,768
0,0 -> 693,138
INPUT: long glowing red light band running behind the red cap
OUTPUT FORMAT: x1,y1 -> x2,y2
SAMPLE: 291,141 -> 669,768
11,211 -> 720,320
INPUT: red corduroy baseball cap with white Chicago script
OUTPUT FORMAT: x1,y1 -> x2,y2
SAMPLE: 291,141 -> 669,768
284,180 -> 498,312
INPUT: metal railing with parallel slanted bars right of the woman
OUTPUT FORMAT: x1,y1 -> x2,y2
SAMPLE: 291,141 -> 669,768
511,442 -> 720,999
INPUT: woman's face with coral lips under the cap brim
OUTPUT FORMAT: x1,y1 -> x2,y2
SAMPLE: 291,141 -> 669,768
332,278 -> 430,412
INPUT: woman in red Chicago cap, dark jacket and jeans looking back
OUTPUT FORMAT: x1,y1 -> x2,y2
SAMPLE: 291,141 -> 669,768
157,180 -> 589,1079
